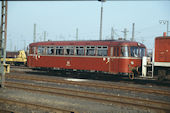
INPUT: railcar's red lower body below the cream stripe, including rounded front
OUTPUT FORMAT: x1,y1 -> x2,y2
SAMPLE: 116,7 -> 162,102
28,56 -> 141,74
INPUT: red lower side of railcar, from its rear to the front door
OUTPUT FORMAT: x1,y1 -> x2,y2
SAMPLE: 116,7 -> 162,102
28,56 -> 109,72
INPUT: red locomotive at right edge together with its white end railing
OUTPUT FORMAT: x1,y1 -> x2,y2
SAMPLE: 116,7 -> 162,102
142,36 -> 170,80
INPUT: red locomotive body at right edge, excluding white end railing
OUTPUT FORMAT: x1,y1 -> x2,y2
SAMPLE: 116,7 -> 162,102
153,36 -> 170,80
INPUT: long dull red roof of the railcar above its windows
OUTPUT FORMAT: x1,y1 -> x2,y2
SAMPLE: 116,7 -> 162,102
30,40 -> 145,47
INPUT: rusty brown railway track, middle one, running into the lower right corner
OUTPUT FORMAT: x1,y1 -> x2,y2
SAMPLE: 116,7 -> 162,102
5,81 -> 170,113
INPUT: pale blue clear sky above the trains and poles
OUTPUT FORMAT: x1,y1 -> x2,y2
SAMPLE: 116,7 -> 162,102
3,0 -> 170,51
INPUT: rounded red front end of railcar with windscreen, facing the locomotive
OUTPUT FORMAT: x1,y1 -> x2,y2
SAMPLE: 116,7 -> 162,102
110,42 -> 146,78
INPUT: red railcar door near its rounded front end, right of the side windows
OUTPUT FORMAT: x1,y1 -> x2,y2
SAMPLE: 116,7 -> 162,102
109,46 -> 119,74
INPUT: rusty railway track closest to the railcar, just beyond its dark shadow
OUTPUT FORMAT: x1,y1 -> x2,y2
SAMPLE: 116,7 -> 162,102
6,75 -> 170,96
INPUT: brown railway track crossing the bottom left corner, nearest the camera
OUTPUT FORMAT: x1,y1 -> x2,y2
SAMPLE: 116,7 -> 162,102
0,98 -> 77,113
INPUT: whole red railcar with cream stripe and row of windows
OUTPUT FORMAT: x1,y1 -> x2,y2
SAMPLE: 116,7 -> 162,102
27,40 -> 146,77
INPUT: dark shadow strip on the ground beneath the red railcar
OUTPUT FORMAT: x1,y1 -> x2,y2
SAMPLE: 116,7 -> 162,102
26,70 -> 170,87
